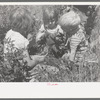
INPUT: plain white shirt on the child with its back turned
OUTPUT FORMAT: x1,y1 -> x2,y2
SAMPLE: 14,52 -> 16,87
4,30 -> 29,53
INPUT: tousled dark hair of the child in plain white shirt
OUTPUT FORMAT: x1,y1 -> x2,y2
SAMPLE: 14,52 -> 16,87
9,7 -> 35,37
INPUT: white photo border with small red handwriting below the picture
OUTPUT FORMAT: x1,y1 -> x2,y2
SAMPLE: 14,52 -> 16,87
0,2 -> 100,98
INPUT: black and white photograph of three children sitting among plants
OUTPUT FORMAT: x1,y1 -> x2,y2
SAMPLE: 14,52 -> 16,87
0,4 -> 100,82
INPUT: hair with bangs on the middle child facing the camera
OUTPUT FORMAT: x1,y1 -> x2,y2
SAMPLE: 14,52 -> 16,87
43,7 -> 58,24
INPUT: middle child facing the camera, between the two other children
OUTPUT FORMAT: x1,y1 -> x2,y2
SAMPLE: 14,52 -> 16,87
36,7 -> 63,57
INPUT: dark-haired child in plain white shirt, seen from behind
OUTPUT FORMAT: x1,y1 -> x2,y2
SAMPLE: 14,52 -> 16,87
4,8 -> 45,68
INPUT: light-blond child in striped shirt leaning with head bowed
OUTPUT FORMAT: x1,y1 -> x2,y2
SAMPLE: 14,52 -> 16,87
59,11 -> 86,61
